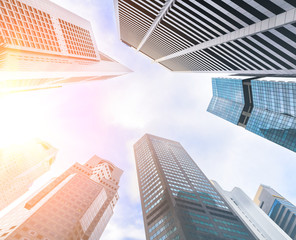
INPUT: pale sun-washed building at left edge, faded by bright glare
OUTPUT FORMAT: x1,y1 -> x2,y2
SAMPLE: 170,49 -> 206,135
0,140 -> 57,210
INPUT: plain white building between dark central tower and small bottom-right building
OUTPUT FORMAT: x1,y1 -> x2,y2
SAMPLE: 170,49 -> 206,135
212,181 -> 291,240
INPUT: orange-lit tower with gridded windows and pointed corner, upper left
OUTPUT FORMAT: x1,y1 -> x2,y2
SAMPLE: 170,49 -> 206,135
0,0 -> 130,92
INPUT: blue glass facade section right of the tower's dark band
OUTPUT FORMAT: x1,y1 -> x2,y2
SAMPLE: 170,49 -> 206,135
246,80 -> 296,152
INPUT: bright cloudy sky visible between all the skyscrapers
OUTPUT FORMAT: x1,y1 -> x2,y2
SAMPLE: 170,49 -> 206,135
0,0 -> 296,240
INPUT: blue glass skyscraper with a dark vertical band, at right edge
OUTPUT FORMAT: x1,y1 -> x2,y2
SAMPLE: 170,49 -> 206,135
208,78 -> 296,152
